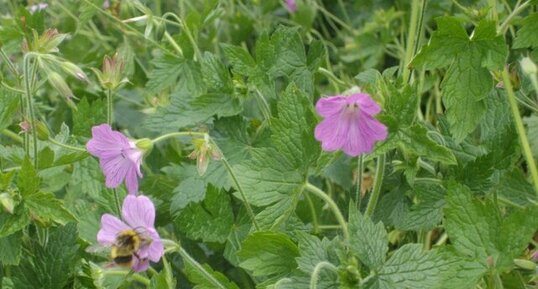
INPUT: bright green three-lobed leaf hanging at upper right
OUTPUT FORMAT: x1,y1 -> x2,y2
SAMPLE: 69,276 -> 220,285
412,17 -> 508,142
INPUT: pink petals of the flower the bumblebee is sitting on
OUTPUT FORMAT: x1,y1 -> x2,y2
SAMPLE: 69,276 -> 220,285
97,195 -> 164,272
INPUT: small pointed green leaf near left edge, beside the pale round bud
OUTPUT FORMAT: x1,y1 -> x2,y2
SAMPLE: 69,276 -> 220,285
25,192 -> 76,225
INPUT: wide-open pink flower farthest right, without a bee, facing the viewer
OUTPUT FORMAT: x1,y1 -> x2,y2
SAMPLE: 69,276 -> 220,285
315,93 -> 387,156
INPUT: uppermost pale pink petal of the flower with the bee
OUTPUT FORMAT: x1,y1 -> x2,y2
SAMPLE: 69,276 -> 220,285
122,195 -> 155,229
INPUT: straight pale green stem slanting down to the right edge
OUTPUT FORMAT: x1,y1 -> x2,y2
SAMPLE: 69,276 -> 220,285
502,67 -> 538,194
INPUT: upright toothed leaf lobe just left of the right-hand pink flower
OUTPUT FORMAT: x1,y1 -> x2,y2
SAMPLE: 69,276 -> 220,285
271,84 -> 320,171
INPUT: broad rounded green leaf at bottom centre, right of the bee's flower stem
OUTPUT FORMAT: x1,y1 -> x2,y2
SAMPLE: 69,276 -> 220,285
237,231 -> 299,276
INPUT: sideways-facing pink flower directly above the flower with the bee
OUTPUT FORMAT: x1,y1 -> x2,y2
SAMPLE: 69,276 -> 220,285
86,124 -> 144,194
